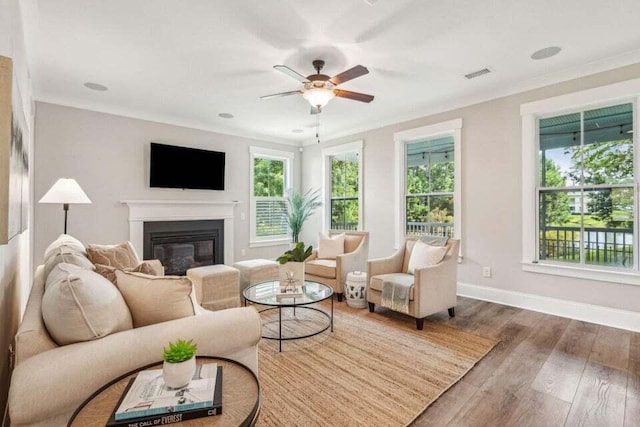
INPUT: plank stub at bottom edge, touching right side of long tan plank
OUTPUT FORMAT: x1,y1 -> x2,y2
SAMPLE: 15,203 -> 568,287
505,390 -> 571,427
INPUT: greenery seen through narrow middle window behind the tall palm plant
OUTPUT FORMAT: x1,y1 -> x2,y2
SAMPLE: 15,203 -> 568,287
330,152 -> 360,230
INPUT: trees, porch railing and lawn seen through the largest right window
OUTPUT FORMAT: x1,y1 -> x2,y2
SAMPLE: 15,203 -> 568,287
538,104 -> 637,268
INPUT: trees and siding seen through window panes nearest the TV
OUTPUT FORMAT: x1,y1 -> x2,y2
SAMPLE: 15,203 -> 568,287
253,156 -> 288,238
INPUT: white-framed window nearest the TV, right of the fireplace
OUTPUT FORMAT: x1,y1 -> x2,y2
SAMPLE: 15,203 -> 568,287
250,147 -> 293,247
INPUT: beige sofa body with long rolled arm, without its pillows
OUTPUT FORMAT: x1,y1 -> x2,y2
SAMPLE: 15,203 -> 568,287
9,266 -> 261,426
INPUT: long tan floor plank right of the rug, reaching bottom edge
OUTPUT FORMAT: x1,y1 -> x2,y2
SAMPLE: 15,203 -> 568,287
452,317 -> 570,425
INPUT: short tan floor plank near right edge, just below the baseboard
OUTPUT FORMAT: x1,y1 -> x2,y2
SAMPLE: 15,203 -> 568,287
590,326 -> 631,371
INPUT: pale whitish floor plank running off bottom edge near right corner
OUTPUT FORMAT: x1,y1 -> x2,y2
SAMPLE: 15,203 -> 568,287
566,361 -> 627,427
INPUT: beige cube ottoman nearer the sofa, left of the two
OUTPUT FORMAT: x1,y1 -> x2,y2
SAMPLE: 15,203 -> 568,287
187,264 -> 240,311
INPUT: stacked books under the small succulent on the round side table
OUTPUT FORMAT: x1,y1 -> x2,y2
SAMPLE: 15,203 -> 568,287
107,363 -> 222,427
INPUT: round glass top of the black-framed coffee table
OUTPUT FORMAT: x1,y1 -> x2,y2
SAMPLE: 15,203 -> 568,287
242,280 -> 333,306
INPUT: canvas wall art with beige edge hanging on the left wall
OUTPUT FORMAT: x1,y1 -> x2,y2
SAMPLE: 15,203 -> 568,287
0,56 -> 31,245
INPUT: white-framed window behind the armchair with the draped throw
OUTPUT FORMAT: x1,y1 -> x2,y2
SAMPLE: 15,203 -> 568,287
394,119 -> 462,251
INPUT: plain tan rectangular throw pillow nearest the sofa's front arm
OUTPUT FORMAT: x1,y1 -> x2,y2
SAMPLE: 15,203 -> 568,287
116,270 -> 195,328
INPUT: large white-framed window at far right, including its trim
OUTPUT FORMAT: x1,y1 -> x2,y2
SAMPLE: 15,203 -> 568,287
520,79 -> 640,285
